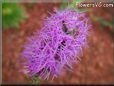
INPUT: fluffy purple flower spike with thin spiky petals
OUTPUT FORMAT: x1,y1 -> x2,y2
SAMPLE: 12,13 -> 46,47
22,9 -> 90,79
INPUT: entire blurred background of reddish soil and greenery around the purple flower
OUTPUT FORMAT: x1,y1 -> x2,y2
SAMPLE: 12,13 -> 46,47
2,2 -> 114,84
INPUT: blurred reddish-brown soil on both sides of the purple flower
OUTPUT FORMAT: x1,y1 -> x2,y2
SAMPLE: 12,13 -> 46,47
2,3 -> 114,84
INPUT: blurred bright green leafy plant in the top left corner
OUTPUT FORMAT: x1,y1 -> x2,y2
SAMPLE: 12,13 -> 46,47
2,3 -> 27,28
